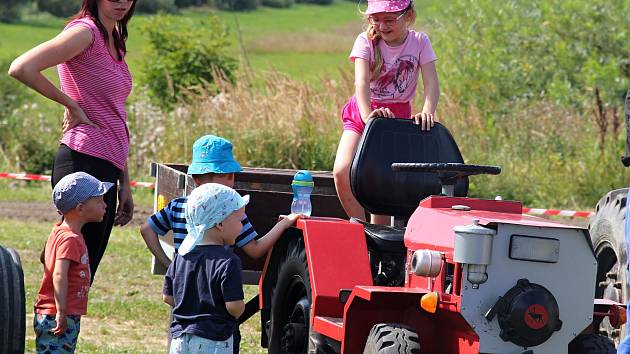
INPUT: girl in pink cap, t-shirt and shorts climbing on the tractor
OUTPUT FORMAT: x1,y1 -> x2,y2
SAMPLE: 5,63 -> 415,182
333,0 -> 439,224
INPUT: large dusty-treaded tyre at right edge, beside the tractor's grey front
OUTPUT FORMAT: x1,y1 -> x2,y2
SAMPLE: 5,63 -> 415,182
589,188 -> 630,345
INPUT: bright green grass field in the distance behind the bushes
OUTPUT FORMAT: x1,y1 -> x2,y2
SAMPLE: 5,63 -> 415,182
0,1 -> 361,79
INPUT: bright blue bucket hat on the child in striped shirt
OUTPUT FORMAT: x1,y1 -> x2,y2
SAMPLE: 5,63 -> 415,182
188,135 -> 241,175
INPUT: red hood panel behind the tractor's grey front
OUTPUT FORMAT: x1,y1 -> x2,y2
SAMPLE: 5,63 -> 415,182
405,196 -> 580,260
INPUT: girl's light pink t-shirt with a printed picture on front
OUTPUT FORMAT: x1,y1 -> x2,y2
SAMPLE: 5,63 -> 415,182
350,30 -> 437,103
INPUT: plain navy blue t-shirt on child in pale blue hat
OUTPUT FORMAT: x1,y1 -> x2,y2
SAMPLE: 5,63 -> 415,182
163,245 -> 244,341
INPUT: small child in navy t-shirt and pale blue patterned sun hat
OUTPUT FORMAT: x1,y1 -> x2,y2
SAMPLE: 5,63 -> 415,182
163,183 -> 249,354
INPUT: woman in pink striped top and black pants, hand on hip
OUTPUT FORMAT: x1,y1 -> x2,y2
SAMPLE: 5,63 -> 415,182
9,0 -> 136,280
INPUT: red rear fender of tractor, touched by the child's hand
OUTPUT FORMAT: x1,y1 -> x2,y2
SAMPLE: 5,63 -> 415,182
296,218 -> 372,317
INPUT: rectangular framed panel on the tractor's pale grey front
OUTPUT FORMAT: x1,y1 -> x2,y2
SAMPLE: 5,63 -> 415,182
510,235 -> 560,263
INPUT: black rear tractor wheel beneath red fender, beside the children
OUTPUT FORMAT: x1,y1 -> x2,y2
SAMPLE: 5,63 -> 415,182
269,238 -> 338,354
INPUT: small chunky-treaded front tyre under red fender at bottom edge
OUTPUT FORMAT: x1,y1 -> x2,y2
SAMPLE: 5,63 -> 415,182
363,323 -> 421,354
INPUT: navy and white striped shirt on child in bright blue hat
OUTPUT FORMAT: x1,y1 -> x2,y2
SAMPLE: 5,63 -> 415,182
147,197 -> 258,249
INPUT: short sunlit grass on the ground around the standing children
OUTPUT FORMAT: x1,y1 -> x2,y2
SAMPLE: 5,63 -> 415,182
0,219 -> 263,354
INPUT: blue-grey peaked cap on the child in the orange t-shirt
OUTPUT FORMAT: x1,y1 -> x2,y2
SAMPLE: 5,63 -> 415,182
52,172 -> 114,213
